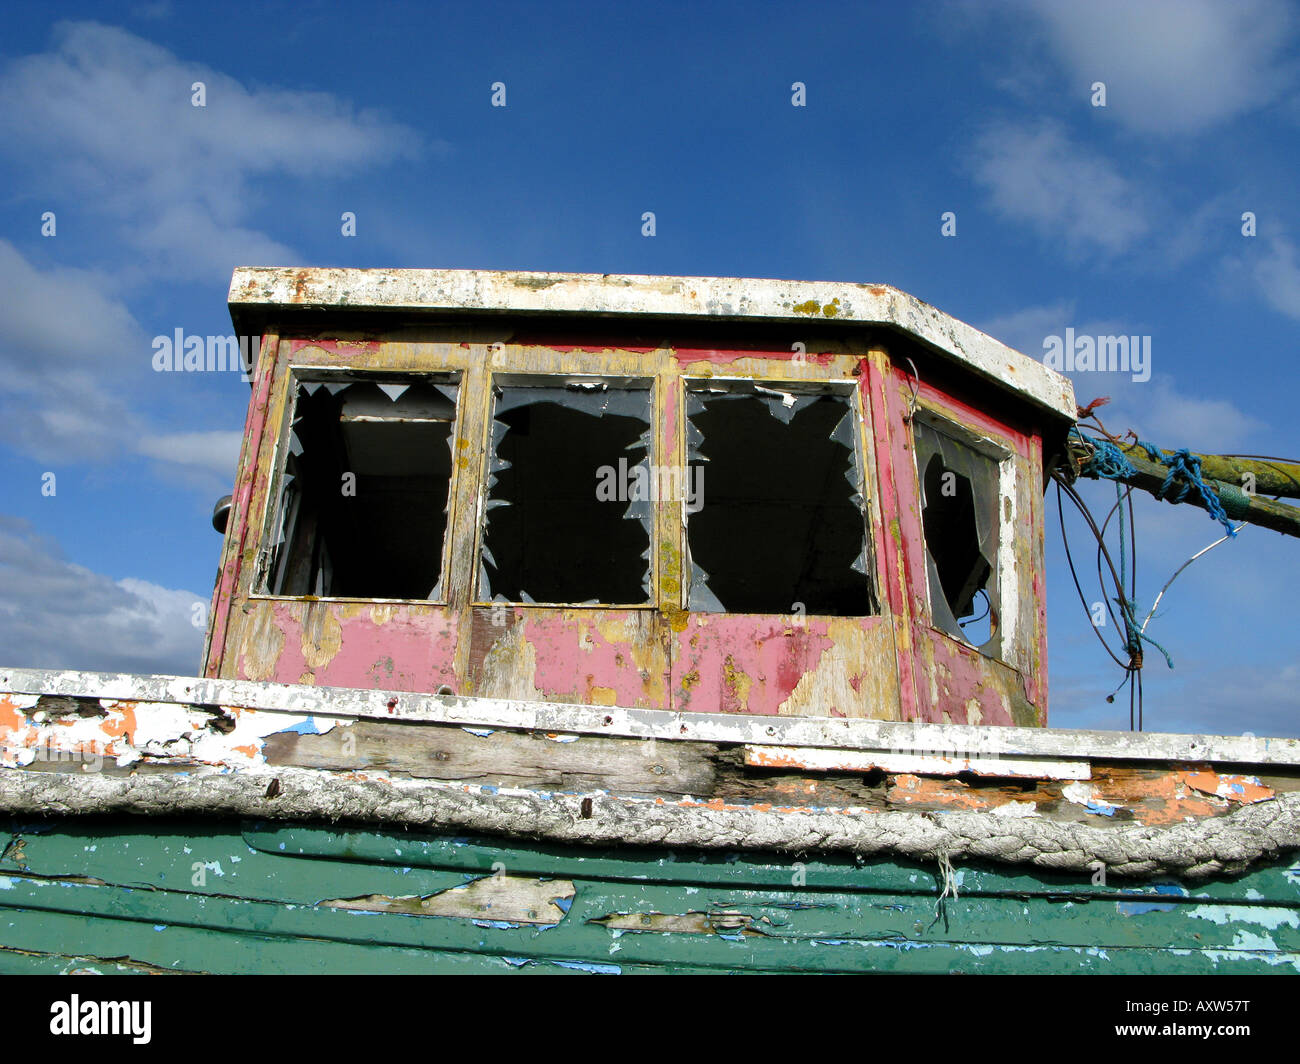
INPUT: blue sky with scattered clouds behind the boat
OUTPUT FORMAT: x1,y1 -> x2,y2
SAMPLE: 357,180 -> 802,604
0,0 -> 1300,735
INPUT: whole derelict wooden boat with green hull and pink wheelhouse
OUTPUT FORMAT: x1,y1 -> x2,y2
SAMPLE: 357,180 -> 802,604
0,269 -> 1300,972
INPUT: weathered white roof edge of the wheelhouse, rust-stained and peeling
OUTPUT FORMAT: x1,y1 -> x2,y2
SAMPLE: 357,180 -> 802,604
230,267 -> 1075,421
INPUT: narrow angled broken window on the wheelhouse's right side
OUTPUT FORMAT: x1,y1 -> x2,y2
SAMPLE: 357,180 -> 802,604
914,420 -> 1001,656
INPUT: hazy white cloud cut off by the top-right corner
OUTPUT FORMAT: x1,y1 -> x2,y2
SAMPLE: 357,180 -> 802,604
1024,0 -> 1297,137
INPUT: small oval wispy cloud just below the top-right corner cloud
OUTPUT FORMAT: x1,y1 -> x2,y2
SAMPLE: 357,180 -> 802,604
970,121 -> 1151,258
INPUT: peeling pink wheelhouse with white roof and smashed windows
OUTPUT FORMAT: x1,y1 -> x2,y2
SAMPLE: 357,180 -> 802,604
204,269 -> 1075,726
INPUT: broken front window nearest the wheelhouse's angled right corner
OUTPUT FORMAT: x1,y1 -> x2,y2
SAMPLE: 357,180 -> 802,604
686,381 -> 879,617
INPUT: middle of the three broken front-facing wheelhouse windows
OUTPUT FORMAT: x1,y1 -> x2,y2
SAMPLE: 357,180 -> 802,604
478,379 -> 653,605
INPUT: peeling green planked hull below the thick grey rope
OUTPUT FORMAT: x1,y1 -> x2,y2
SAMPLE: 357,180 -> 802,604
0,818 -> 1300,973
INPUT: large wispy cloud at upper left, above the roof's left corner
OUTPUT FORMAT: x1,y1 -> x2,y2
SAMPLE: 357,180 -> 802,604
0,22 -> 418,281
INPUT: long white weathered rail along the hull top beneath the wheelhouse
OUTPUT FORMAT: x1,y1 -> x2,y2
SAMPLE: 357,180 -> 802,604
0,667 -> 1300,766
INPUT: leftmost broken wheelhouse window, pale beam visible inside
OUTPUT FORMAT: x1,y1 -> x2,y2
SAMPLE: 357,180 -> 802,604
267,377 -> 456,600
